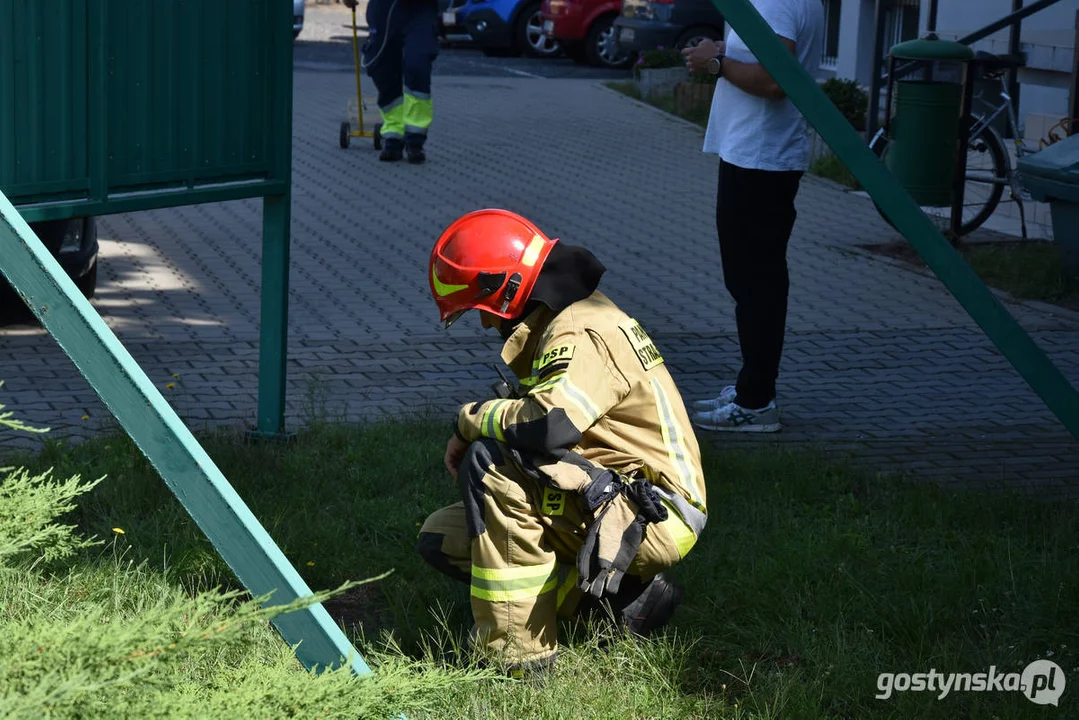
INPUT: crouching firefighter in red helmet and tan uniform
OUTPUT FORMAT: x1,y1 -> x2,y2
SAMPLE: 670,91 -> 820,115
418,209 -> 707,675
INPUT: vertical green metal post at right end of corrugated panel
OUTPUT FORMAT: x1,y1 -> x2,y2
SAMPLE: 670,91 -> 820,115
255,0 -> 292,438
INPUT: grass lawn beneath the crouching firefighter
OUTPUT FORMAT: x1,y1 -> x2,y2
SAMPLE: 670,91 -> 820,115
0,420 -> 1079,720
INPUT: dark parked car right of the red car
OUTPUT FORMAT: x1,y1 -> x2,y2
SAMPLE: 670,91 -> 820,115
614,0 -> 726,52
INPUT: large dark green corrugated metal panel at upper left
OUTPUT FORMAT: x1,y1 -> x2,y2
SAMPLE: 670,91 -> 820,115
0,0 -> 292,221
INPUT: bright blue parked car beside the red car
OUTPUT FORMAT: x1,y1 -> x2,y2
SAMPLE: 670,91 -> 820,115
441,0 -> 561,57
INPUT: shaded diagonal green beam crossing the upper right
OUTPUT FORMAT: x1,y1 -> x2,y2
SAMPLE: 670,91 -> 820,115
712,0 -> 1079,438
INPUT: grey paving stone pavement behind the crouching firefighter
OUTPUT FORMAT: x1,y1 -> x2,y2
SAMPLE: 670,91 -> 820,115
0,71 -> 1079,493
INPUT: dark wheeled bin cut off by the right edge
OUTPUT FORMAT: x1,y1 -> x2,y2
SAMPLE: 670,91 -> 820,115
1019,135 -> 1079,280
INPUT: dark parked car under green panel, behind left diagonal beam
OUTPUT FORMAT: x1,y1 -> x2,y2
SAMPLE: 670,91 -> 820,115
0,217 -> 97,323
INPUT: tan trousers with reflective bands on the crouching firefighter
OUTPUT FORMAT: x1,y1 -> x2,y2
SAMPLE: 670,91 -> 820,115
418,438 -> 696,668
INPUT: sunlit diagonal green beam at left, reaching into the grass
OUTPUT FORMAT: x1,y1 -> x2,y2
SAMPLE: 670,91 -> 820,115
0,193 -> 370,675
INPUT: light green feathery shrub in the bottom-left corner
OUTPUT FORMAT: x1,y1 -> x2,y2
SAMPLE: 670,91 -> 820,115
0,390 -> 492,719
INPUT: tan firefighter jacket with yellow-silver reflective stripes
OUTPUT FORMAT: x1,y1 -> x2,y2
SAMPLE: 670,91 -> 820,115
456,290 -> 707,547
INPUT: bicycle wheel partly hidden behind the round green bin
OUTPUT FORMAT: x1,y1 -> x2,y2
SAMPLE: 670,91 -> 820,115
870,121 -> 1011,237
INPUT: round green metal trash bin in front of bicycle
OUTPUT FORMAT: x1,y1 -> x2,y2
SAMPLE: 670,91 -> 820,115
885,38 -> 974,207
